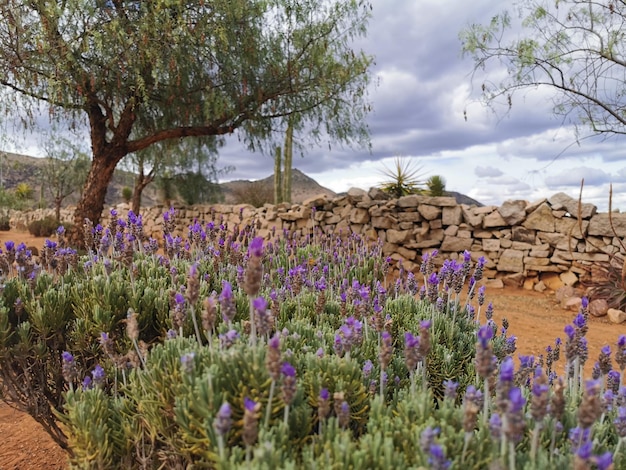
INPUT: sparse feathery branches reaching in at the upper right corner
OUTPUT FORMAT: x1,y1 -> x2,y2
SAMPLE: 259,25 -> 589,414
460,0 -> 626,139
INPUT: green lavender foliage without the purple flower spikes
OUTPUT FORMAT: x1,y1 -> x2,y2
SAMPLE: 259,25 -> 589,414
0,211 -> 626,469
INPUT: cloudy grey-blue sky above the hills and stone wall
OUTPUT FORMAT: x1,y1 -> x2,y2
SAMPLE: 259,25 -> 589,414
213,0 -> 626,210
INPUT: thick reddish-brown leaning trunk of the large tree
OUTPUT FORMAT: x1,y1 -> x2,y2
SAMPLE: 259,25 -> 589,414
69,152 -> 124,247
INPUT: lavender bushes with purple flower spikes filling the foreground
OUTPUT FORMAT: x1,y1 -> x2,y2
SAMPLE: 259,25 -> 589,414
0,211 -> 626,469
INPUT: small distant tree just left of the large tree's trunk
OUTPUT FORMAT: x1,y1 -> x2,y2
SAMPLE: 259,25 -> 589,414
41,135 -> 89,223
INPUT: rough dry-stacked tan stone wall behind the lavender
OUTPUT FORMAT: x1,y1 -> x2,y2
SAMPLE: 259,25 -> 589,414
11,188 -> 626,289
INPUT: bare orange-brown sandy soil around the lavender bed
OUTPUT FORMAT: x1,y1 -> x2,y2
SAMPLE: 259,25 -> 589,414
0,232 -> 626,470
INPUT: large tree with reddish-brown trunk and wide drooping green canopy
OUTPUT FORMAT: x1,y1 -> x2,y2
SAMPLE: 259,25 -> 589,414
0,0 -> 372,246
